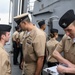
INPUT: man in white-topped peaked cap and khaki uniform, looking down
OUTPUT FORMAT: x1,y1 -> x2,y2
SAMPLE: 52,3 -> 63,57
14,13 -> 46,75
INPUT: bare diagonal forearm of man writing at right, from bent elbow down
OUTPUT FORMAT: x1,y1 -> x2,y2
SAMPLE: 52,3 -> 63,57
53,50 -> 75,67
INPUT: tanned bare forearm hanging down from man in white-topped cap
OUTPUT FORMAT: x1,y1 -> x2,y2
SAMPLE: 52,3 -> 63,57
35,56 -> 44,75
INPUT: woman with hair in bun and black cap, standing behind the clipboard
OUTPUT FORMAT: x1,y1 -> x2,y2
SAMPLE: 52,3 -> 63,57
46,29 -> 59,71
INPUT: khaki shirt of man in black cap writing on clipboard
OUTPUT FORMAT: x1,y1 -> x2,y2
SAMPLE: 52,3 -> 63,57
55,35 -> 75,64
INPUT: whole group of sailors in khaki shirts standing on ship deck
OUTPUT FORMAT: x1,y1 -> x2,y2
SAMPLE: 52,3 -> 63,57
0,9 -> 75,75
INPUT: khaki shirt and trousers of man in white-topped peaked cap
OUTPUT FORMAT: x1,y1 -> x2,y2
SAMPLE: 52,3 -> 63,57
23,26 -> 46,75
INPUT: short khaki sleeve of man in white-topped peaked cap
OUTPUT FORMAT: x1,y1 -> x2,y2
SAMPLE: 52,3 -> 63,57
33,35 -> 46,57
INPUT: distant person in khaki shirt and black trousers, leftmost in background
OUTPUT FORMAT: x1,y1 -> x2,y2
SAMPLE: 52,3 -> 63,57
12,26 -> 20,65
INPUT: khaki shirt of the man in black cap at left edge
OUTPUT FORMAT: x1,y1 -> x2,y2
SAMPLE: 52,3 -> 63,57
0,44 -> 11,75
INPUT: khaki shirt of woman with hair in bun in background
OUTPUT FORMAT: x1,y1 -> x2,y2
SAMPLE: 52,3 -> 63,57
46,38 -> 58,62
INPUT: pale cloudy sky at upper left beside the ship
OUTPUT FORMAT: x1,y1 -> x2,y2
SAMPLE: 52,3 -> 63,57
0,0 -> 10,24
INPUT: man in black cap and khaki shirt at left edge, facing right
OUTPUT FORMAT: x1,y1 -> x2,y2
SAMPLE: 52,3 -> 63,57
0,24 -> 11,75
